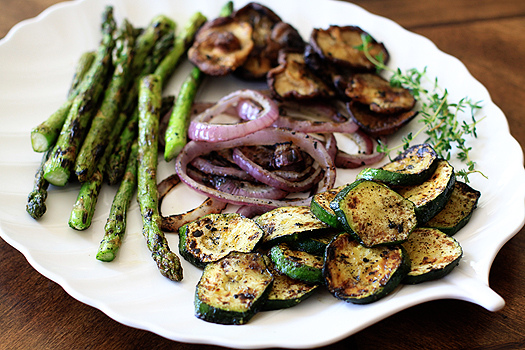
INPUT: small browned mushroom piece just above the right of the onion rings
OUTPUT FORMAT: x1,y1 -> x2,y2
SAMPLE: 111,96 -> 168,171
267,50 -> 335,100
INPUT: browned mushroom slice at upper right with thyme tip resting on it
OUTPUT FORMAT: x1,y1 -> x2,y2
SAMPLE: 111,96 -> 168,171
310,25 -> 389,71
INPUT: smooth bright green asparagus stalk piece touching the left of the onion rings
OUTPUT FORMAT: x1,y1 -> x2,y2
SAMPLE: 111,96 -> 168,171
164,67 -> 204,162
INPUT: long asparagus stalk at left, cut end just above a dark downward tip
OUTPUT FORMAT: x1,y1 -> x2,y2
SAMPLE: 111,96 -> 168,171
44,6 -> 115,186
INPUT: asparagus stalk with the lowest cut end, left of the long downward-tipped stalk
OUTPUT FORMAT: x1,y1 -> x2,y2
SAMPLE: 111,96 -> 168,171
97,141 -> 138,262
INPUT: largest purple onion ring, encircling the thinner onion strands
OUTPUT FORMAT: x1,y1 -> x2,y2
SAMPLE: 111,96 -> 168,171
175,128 -> 335,207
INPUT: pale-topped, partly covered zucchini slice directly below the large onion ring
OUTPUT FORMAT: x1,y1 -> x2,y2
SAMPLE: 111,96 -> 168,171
256,206 -> 330,245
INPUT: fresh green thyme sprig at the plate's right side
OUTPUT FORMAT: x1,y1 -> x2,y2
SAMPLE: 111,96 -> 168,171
358,34 -> 485,182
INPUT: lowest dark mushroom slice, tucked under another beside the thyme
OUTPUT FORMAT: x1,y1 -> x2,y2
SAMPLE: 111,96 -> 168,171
347,101 -> 418,137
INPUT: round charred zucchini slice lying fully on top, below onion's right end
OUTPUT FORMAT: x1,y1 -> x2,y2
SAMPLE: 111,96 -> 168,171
330,180 -> 417,247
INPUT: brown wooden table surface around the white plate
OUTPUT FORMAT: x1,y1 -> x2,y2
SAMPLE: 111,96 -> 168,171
0,0 -> 525,350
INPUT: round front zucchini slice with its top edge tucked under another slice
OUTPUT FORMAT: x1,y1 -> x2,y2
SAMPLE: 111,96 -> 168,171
323,233 -> 410,304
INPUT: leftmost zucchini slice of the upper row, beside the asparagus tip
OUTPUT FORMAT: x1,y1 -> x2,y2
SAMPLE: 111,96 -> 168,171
179,213 -> 264,267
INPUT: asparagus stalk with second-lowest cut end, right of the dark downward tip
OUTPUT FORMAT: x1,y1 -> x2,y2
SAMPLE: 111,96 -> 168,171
69,113 -> 127,231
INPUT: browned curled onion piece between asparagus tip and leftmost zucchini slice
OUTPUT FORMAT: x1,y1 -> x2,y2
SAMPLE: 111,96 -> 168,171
158,174 -> 228,232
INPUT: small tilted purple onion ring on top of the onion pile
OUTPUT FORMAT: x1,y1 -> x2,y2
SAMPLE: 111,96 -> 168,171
188,89 -> 279,142
